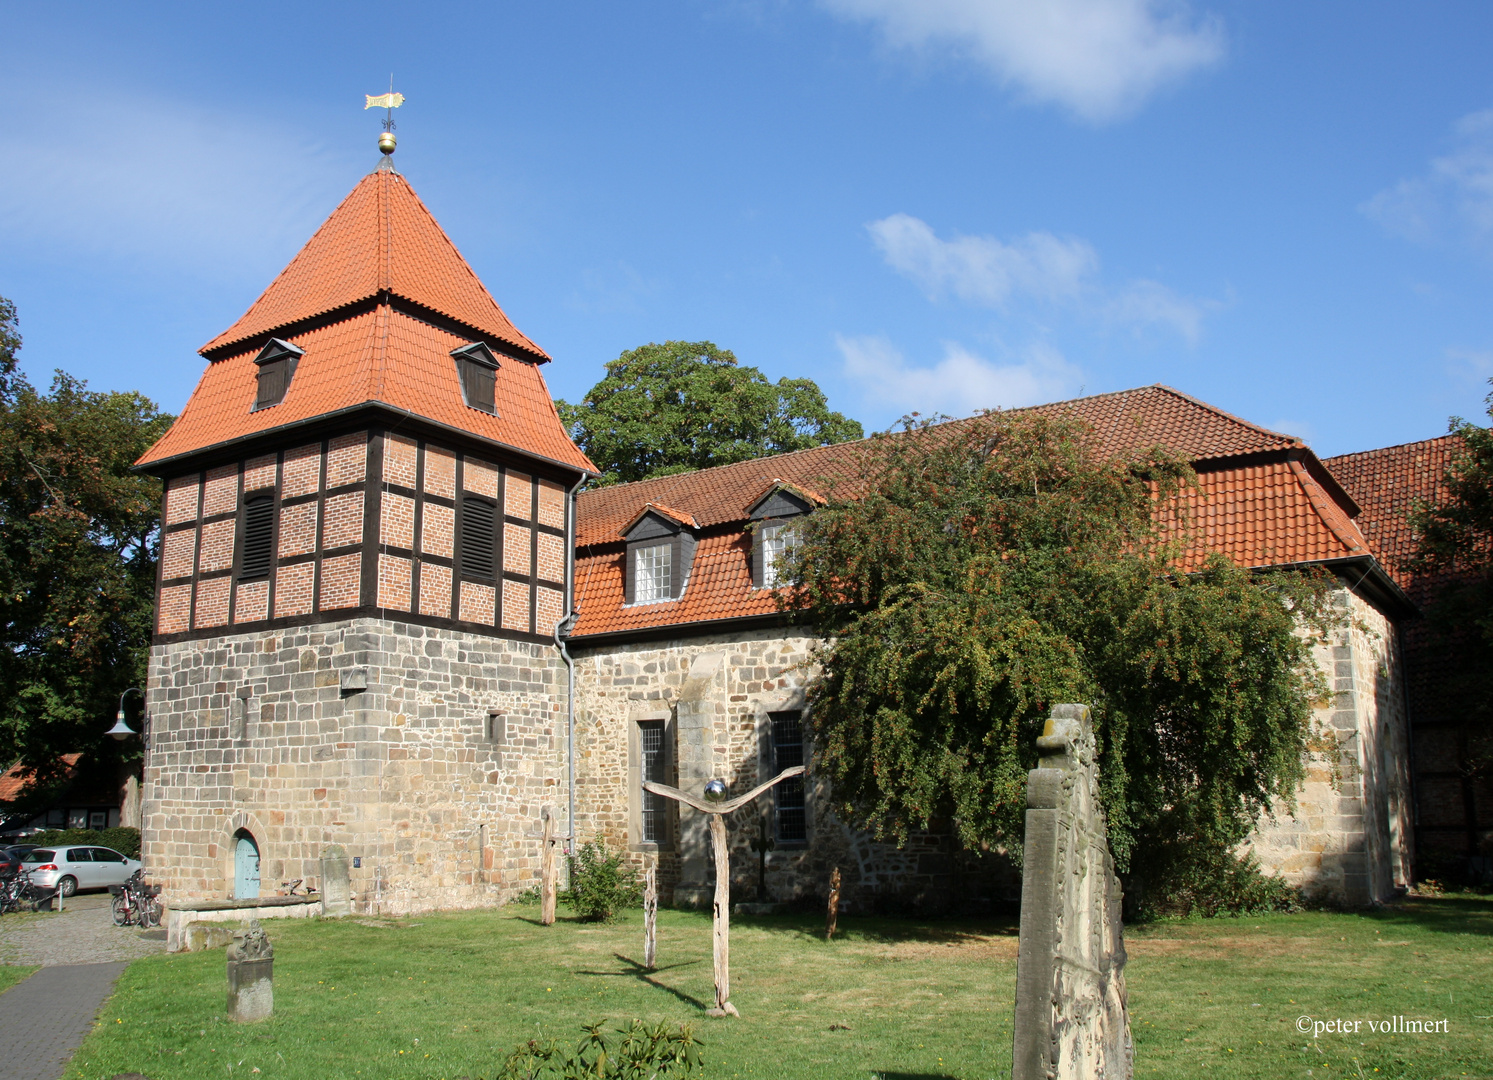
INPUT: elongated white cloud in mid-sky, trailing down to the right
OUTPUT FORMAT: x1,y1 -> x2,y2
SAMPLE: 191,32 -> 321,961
866,214 -> 1215,342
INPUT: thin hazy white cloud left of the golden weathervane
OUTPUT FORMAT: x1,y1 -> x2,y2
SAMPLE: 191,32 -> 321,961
0,84 -> 352,278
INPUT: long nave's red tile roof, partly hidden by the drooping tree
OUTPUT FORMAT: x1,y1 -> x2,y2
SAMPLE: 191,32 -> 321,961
575,385 -> 1369,636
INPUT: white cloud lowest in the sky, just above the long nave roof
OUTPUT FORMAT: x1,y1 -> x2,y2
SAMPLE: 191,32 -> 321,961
835,336 -> 1081,417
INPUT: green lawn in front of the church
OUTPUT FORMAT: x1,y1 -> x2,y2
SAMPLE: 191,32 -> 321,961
67,898 -> 1493,1080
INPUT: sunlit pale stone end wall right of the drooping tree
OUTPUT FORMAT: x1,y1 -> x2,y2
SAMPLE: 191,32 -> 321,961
1251,589 -> 1414,905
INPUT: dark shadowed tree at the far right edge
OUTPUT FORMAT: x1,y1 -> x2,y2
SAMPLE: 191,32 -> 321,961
1408,393 -> 1493,830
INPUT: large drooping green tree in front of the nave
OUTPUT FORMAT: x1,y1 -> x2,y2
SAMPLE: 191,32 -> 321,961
782,414 -> 1332,902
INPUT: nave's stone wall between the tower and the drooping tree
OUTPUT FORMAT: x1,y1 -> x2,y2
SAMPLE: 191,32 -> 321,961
572,629 -> 1003,910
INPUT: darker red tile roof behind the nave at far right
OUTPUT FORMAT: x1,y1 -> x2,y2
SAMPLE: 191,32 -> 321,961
1323,435 -> 1466,599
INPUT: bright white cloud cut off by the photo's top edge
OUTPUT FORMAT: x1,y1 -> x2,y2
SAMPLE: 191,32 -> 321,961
823,0 -> 1224,122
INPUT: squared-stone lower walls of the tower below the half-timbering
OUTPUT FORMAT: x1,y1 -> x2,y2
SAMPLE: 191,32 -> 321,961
142,618 -> 566,913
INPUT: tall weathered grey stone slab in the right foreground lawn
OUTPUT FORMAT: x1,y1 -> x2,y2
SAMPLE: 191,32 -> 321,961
1011,705 -> 1133,1080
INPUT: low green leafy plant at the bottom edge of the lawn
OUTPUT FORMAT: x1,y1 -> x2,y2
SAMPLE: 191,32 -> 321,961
497,1020 -> 703,1080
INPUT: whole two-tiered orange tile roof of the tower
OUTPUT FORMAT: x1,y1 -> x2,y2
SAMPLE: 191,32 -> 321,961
132,172 -> 596,472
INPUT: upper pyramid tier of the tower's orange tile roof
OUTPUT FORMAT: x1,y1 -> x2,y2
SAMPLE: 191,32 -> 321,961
202,169 -> 549,360
